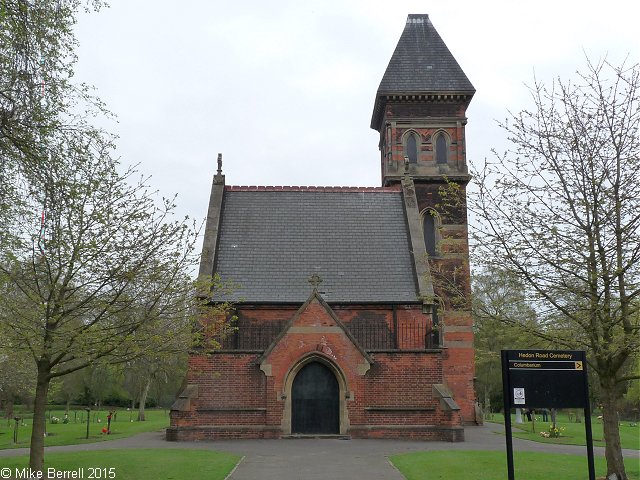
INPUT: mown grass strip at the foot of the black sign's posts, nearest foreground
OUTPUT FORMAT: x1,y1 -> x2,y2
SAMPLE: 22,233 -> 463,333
391,451 -> 640,480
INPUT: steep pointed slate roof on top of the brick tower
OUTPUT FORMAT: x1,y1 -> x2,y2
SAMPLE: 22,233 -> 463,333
378,15 -> 475,95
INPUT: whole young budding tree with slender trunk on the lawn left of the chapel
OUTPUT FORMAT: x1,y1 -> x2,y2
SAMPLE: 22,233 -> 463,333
0,125 -> 205,468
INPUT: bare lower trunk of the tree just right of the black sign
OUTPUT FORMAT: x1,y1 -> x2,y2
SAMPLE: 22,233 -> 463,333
600,379 -> 628,480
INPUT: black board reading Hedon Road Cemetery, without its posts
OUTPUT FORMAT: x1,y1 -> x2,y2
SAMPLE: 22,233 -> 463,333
503,350 -> 588,408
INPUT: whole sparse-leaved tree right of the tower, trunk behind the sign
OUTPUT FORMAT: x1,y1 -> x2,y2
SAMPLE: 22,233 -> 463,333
473,61 -> 640,479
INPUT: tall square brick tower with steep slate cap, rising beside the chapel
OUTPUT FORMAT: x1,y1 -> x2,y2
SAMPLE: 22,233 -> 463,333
371,15 -> 475,428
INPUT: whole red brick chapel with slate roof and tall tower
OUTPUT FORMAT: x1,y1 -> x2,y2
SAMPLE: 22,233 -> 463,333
167,15 -> 475,441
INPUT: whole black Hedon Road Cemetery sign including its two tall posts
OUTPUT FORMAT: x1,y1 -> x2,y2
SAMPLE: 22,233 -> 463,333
501,350 -> 596,480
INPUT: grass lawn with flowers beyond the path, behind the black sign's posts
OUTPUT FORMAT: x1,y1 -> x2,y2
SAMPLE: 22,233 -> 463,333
484,413 -> 640,450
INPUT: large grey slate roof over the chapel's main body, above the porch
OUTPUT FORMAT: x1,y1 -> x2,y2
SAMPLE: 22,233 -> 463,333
215,187 -> 417,303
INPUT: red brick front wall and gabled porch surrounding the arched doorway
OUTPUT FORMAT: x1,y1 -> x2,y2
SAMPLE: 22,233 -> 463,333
167,301 -> 468,441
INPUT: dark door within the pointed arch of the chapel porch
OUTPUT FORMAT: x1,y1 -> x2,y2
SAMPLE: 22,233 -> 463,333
291,362 -> 340,434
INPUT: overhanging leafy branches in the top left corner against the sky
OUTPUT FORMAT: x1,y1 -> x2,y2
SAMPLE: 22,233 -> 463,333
0,0 -> 106,225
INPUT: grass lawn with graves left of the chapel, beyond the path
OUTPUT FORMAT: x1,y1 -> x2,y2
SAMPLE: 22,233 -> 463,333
0,409 -> 169,449
